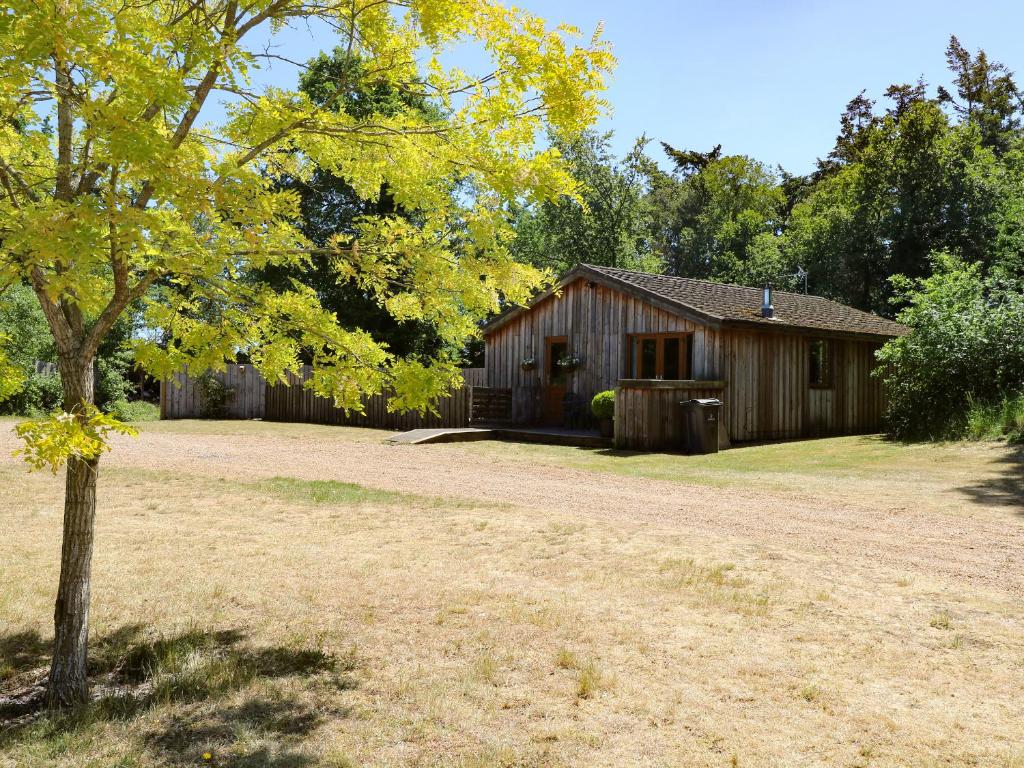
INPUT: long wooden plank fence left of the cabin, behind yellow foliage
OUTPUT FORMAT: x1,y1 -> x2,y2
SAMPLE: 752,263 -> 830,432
160,365 -> 483,430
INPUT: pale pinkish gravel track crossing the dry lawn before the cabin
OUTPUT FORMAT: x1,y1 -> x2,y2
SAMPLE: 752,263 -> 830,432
83,431 -> 1024,597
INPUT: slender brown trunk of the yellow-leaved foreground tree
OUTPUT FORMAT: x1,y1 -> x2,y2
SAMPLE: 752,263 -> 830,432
47,356 -> 99,708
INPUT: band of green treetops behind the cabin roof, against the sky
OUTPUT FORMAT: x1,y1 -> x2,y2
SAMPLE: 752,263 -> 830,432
517,37 -> 1024,316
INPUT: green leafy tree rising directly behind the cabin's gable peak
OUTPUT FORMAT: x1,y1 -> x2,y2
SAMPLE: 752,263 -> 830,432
513,131 -> 657,273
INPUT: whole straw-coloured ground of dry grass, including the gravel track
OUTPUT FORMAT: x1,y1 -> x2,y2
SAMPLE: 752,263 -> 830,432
0,421 -> 1024,768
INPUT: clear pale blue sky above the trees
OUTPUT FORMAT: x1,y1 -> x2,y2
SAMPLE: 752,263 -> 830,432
241,0 -> 1024,173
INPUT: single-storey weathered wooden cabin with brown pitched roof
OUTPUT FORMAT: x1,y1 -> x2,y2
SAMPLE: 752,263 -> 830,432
484,264 -> 905,450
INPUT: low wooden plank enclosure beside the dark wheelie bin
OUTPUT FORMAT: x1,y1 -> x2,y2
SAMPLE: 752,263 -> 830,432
614,379 -> 729,451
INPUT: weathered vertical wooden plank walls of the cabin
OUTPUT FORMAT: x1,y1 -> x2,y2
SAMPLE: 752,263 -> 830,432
485,278 -> 884,450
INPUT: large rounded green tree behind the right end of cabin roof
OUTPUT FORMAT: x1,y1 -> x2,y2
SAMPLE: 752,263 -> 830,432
783,100 -> 1005,314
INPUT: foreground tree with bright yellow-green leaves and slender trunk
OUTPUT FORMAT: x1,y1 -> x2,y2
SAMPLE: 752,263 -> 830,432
0,0 -> 612,706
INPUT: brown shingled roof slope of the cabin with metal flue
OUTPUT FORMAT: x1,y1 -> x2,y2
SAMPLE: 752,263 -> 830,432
581,264 -> 906,336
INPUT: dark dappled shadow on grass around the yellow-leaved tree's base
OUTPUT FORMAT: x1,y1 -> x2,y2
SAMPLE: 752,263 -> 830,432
0,625 -> 355,768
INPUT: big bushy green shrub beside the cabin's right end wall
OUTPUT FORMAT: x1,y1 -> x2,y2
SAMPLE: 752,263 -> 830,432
879,255 -> 1024,439
